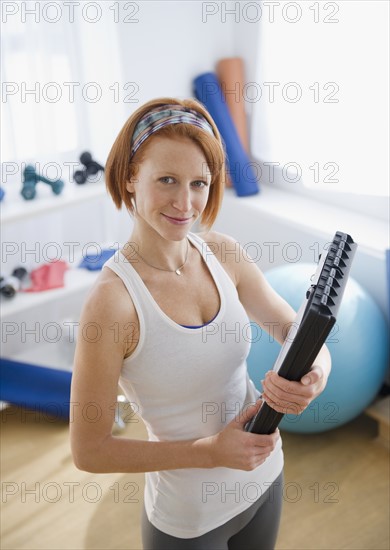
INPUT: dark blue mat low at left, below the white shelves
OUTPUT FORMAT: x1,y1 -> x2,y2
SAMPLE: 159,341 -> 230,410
0,359 -> 72,418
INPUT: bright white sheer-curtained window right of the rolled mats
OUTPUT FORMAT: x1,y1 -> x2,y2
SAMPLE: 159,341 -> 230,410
251,0 -> 389,201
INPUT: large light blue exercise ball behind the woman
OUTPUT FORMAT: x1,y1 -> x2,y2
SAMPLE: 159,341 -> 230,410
248,263 -> 389,433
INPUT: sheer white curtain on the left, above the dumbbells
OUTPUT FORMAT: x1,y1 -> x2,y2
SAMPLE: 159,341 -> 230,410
1,1 -> 123,177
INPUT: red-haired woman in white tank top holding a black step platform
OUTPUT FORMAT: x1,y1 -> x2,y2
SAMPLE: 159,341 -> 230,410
70,98 -> 330,550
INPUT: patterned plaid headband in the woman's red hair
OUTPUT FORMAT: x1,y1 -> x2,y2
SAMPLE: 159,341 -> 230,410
130,105 -> 214,158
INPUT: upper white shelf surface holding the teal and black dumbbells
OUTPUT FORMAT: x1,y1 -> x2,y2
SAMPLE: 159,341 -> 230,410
0,177 -> 107,224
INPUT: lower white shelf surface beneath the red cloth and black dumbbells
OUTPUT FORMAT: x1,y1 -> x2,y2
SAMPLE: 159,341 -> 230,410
1,268 -> 101,319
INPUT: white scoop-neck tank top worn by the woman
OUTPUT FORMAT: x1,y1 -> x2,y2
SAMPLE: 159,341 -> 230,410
104,233 -> 283,538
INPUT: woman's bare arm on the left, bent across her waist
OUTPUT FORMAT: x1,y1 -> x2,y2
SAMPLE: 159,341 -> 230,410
70,272 -> 278,473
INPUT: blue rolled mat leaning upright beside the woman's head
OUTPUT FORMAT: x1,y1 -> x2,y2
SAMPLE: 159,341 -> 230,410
194,73 -> 259,197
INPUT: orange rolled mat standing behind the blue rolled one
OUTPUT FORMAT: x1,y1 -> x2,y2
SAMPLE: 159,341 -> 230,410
216,57 -> 249,153
